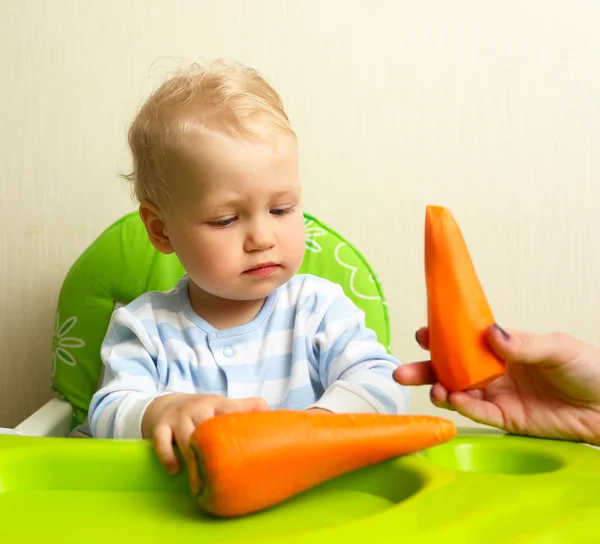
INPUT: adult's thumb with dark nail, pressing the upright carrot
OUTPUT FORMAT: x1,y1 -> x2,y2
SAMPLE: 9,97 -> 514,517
487,324 -> 578,365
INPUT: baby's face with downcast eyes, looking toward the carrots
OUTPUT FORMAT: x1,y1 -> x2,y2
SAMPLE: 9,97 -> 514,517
165,133 -> 305,300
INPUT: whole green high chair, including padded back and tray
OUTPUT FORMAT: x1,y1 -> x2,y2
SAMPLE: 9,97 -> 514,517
0,213 -> 600,544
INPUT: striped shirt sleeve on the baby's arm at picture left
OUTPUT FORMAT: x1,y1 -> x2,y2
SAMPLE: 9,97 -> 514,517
88,308 -> 162,438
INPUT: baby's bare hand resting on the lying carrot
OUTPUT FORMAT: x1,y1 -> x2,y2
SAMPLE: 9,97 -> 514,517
142,393 -> 269,474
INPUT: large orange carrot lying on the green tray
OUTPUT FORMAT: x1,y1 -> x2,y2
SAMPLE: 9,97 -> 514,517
188,410 -> 456,517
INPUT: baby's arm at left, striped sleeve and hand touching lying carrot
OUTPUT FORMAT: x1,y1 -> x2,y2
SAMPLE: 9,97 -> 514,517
89,308 -> 269,474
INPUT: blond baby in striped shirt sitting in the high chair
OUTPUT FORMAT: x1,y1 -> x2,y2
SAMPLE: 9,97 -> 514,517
89,61 -> 407,474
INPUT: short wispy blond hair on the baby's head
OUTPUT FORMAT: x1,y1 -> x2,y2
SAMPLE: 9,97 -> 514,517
123,59 -> 295,204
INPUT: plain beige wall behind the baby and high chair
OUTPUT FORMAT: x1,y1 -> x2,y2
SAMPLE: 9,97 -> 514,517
0,0 -> 600,432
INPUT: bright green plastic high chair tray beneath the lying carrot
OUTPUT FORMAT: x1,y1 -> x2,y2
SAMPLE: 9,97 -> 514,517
0,435 -> 600,544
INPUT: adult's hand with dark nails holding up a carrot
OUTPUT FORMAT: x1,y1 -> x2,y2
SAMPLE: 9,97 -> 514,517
394,325 -> 600,445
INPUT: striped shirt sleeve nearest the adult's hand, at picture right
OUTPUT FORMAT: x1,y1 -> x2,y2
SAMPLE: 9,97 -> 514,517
313,285 -> 408,414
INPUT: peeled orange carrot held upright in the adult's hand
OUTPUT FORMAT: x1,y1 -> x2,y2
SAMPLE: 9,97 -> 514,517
425,206 -> 505,392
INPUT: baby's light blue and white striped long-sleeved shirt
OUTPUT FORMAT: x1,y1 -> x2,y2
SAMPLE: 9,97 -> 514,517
89,275 -> 408,438
